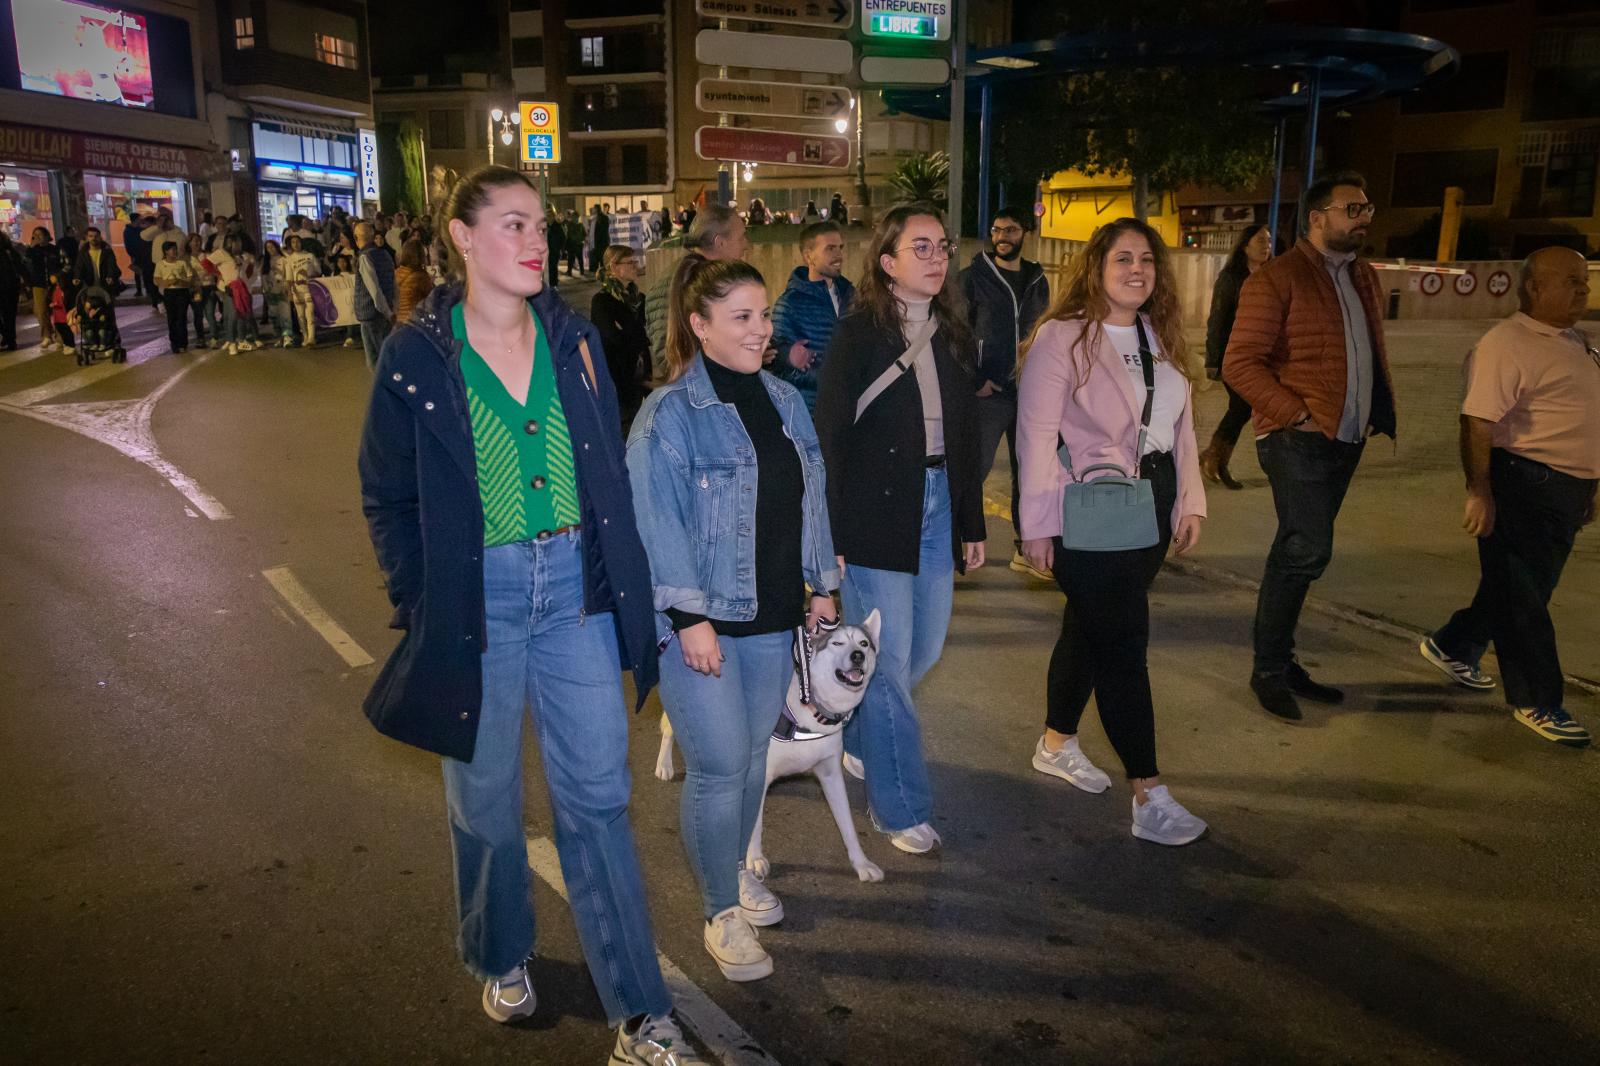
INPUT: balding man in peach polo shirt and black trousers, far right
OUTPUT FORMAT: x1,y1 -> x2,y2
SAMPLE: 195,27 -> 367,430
1421,248 -> 1600,747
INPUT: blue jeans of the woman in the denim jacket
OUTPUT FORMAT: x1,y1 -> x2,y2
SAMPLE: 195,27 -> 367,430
661,631 -> 794,919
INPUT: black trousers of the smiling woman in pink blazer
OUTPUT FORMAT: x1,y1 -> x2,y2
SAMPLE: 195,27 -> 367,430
1045,451 -> 1178,778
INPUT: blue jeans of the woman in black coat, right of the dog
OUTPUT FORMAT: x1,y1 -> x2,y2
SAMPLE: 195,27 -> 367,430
843,467 -> 955,831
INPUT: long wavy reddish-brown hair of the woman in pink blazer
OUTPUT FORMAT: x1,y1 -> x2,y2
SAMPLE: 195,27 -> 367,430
1016,218 -> 1202,389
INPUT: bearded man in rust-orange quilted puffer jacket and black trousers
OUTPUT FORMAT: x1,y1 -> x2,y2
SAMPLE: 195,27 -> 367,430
1222,173 -> 1395,720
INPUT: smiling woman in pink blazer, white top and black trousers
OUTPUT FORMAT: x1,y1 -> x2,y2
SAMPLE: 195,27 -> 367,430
1016,218 -> 1206,845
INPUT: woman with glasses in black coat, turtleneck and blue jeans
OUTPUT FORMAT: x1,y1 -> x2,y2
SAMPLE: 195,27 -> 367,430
816,205 -> 986,855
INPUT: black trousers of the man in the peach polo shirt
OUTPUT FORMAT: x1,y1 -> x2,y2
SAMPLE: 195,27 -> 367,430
1434,448 -> 1597,711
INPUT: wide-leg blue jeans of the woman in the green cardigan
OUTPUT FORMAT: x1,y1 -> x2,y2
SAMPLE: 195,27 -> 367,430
443,530 -> 672,1026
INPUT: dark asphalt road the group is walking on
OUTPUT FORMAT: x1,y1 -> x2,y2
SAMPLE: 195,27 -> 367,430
0,299 -> 1600,1066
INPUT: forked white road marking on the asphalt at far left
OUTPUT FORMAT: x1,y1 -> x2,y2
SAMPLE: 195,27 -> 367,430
0,341 -> 234,520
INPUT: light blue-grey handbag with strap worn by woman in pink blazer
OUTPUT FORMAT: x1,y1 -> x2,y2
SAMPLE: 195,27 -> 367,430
1058,317 -> 1160,552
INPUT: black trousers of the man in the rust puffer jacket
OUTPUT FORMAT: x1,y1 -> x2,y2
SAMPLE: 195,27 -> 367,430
1254,429 -> 1366,674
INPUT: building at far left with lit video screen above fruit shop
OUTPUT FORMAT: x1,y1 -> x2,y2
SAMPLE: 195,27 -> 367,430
0,0 -> 229,269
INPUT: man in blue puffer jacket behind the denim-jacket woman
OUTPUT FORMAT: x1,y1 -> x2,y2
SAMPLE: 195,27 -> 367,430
773,221 -> 856,411
